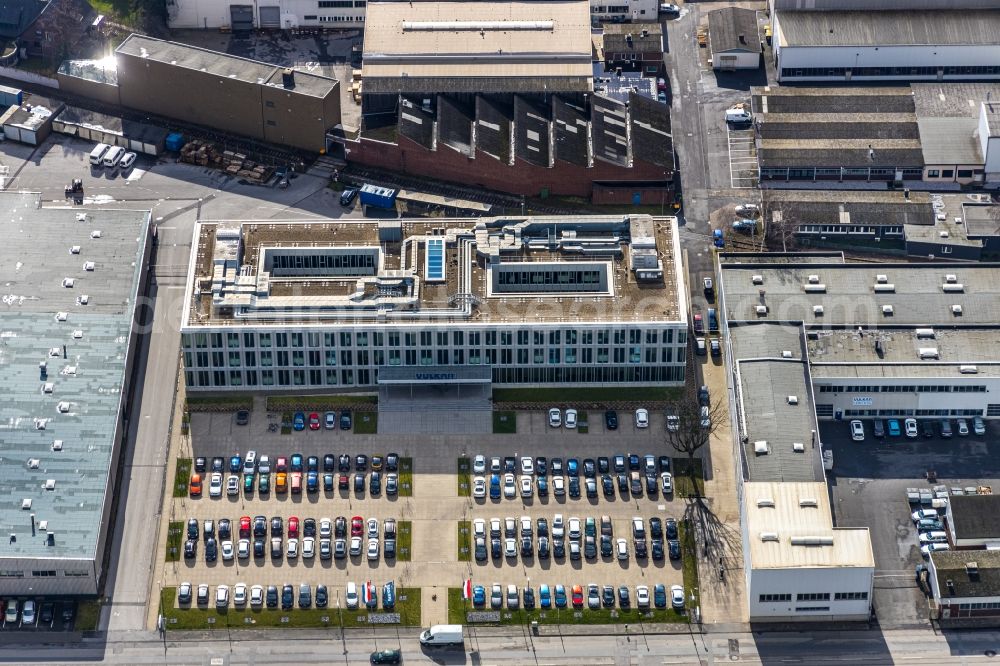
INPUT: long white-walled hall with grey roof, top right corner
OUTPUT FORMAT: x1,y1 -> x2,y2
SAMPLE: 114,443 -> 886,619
770,0 -> 1000,83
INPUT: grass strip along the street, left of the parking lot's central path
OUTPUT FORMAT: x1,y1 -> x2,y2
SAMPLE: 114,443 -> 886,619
160,587 -> 420,631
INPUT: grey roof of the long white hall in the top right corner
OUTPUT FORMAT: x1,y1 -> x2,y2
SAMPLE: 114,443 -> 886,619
775,9 -> 1000,47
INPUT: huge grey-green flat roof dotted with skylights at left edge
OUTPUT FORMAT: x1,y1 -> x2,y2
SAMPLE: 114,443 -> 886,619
0,192 -> 149,558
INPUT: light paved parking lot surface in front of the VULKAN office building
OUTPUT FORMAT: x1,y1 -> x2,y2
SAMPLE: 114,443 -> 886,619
161,402 -> 696,624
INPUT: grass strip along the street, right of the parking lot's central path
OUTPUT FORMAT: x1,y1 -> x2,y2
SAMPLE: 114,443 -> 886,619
448,587 -> 690,626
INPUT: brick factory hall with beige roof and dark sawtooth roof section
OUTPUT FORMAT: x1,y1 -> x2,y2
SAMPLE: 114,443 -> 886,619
340,0 -> 674,201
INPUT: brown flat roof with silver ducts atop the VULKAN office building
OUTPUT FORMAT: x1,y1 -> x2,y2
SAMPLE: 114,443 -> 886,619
184,215 -> 686,326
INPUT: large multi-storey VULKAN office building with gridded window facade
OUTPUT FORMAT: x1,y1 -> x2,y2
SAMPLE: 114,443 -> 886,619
181,215 -> 687,410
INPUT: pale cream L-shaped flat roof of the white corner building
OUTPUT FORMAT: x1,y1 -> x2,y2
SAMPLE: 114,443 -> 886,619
743,481 -> 875,569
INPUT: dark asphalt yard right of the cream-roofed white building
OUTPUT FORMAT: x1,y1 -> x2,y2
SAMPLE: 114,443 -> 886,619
820,419 -> 1000,627
